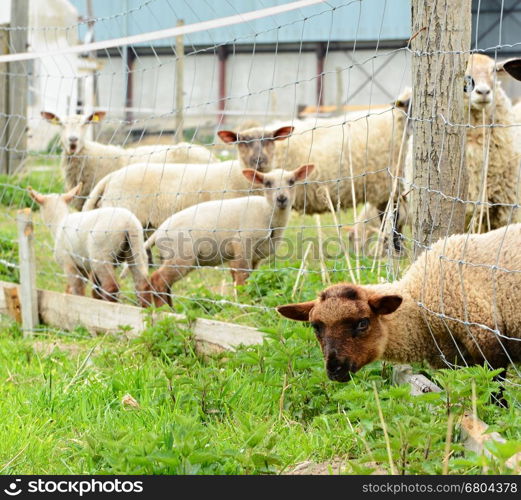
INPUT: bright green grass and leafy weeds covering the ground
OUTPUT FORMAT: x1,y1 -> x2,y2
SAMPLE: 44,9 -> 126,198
0,166 -> 521,474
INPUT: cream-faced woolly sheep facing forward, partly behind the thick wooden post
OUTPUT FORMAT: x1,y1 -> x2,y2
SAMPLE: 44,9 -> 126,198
405,54 -> 521,229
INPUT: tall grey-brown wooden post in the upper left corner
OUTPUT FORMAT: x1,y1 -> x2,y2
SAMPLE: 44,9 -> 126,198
7,0 -> 29,174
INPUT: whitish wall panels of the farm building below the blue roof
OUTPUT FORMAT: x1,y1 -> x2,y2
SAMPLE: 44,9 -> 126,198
94,50 -> 410,130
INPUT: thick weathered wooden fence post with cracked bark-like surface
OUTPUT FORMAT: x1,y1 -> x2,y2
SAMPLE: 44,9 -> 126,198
411,0 -> 472,253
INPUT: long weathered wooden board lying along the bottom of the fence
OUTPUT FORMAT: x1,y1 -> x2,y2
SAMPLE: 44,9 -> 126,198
0,281 -> 264,354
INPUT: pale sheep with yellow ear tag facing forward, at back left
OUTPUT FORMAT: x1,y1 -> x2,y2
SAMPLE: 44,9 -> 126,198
41,111 -> 216,210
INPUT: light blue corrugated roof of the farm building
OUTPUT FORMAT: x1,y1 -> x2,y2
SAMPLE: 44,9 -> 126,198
72,0 -> 410,46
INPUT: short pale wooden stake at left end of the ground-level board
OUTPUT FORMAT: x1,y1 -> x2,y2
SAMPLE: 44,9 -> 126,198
16,208 -> 39,336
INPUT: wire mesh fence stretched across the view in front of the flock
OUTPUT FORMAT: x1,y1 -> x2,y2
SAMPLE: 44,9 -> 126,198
0,0 -> 521,398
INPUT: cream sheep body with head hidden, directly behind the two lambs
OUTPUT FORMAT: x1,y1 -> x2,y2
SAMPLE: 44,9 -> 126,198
83,161 -> 270,228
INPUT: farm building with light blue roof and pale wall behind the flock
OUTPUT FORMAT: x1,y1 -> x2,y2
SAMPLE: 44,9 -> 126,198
72,0 -> 521,123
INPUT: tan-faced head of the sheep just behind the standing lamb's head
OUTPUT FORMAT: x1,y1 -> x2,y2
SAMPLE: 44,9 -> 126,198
217,126 -> 294,172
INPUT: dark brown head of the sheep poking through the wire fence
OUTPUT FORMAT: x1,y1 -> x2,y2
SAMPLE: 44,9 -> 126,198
277,283 -> 402,382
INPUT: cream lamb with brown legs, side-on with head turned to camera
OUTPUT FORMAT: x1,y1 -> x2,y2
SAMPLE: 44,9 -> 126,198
145,165 -> 314,305
